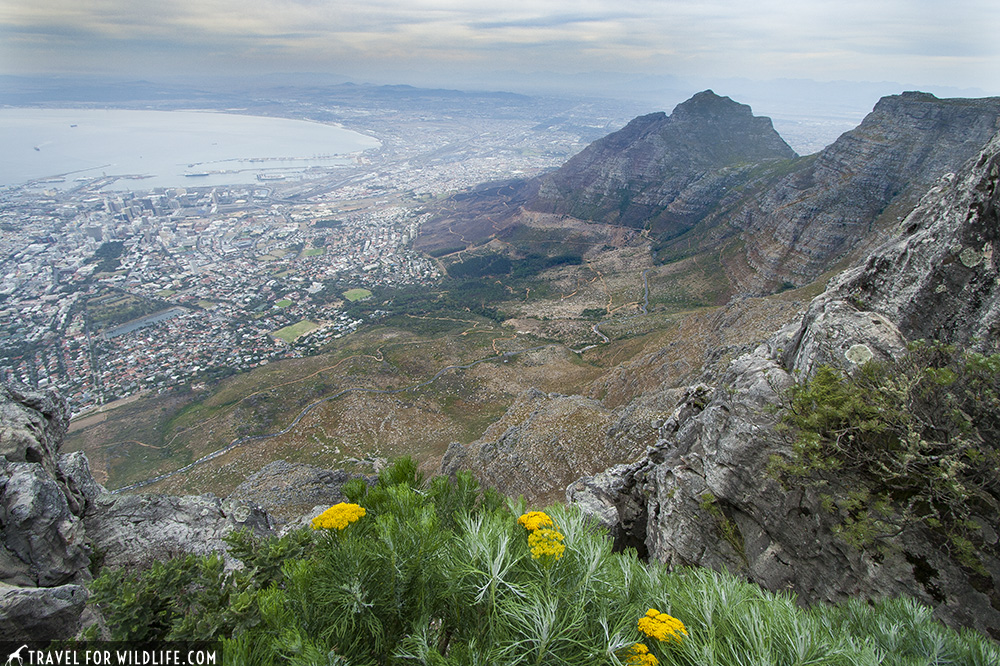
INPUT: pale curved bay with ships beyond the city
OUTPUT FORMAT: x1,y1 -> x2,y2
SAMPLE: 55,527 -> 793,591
0,108 -> 380,190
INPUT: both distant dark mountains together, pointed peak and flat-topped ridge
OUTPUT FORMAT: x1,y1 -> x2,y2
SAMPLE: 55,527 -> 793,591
417,91 -> 1000,294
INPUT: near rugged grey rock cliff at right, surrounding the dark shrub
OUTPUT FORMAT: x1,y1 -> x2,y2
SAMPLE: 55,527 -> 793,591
567,128 -> 1000,637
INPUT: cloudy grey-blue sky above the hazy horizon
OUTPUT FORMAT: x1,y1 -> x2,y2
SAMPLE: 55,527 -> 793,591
0,0 -> 1000,94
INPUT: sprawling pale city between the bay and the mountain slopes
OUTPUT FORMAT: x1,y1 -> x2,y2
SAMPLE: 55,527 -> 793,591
0,92 -> 628,414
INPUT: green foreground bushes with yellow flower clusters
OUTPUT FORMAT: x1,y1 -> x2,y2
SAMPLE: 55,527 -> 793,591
93,459 -> 1000,666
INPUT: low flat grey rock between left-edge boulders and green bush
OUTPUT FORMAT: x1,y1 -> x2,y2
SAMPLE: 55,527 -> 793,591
84,494 -> 274,567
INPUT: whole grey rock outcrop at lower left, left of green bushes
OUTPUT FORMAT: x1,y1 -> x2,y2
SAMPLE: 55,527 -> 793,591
0,385 -> 272,641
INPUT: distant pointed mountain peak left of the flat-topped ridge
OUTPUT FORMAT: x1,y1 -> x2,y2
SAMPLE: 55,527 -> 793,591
527,90 -> 795,237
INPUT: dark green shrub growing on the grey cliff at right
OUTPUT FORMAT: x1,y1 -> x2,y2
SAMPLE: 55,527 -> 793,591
772,341 -> 1000,571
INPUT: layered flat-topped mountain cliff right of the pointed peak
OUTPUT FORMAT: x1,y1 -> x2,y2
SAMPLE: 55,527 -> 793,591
730,93 -> 1000,291
